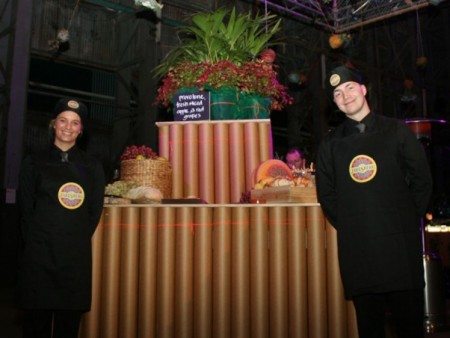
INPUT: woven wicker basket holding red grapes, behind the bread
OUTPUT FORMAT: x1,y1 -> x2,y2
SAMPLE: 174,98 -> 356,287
120,157 -> 172,198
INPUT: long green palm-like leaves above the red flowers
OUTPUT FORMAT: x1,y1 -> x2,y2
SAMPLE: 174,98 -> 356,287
155,8 -> 281,77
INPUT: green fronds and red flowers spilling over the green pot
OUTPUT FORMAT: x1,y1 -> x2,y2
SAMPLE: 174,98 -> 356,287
155,8 -> 292,110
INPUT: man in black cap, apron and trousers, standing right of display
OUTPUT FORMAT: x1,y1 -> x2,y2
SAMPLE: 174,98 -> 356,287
316,66 -> 432,338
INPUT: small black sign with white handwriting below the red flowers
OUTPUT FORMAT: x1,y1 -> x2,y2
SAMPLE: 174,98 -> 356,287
173,92 -> 210,121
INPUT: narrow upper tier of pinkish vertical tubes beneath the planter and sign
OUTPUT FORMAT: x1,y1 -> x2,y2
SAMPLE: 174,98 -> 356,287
157,119 -> 273,204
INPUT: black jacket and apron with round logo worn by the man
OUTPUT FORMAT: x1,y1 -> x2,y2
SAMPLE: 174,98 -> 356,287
316,113 -> 432,298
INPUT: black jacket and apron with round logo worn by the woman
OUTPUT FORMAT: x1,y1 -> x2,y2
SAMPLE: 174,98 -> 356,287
18,146 -> 105,310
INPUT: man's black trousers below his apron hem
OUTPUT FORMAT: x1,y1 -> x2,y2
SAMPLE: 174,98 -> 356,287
353,289 -> 424,338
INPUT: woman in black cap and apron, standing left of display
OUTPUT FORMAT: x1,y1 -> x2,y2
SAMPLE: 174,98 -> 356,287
18,99 -> 105,338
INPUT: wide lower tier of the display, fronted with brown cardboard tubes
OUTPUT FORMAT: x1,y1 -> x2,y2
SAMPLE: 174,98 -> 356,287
80,203 -> 357,338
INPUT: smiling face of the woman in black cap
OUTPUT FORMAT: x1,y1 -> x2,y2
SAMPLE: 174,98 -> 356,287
53,110 -> 83,150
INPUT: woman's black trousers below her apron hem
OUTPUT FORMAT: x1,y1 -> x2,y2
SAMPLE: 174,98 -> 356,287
23,309 -> 82,338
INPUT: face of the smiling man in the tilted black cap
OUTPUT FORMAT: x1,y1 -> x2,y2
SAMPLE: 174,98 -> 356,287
333,81 -> 370,121
